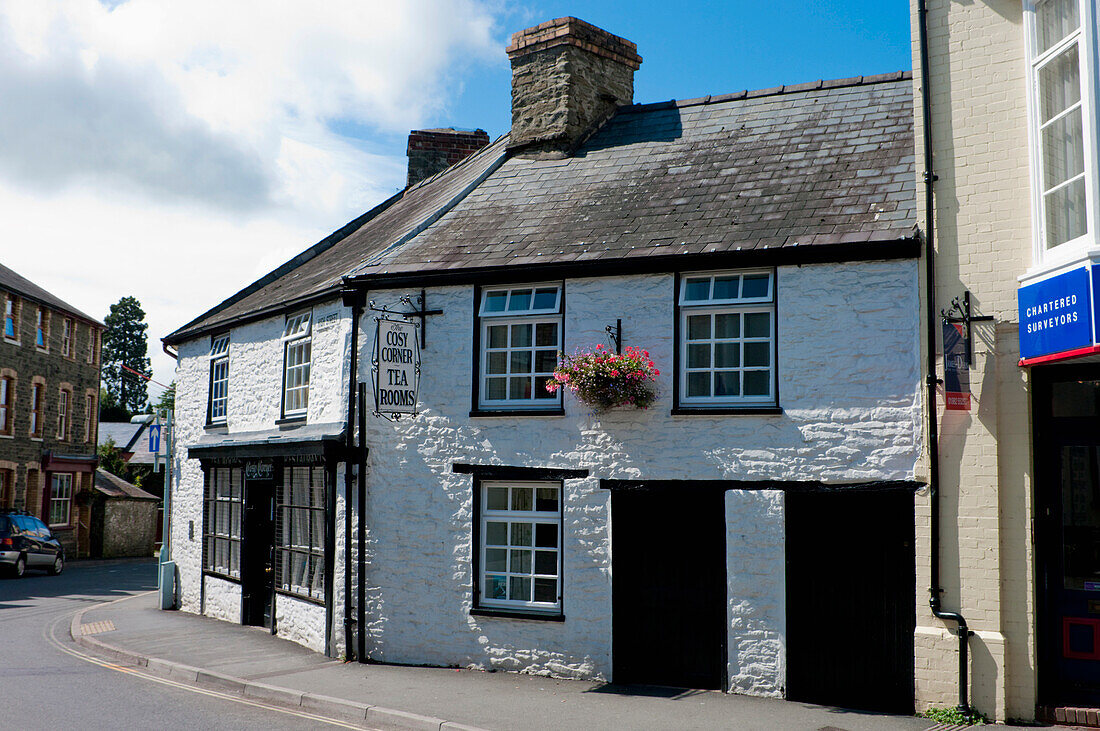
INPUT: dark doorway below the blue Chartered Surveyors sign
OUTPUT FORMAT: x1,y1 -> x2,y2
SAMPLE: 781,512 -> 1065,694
1035,366 -> 1100,706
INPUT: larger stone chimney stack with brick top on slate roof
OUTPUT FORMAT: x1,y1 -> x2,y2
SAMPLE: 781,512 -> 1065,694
507,18 -> 641,156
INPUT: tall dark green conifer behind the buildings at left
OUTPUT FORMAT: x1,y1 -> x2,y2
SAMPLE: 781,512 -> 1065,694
102,297 -> 153,419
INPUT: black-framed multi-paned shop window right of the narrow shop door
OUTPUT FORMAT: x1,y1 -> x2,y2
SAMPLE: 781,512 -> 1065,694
275,465 -> 325,601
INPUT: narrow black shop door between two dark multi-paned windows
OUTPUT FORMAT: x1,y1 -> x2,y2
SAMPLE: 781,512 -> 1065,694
241,477 -> 275,629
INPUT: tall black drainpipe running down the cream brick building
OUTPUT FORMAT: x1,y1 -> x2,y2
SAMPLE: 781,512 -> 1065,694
916,0 -> 971,713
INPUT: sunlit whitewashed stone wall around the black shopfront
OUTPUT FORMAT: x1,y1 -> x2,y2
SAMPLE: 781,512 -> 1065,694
172,301 -> 351,652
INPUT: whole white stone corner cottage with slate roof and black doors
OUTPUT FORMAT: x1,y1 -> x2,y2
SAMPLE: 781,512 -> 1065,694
165,19 -> 922,710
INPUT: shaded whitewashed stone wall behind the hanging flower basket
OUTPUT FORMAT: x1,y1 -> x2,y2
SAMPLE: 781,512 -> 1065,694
360,262 -> 921,695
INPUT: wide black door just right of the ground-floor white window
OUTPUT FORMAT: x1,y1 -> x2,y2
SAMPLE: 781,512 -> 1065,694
612,483 -> 726,689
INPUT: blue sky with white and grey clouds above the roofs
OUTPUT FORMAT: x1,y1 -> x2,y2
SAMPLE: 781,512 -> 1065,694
0,0 -> 912,398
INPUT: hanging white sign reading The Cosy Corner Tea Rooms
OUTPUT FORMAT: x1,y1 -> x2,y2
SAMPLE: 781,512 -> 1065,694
373,318 -> 420,414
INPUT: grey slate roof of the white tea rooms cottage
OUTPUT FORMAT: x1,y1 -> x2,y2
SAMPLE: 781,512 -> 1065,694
165,71 -> 916,343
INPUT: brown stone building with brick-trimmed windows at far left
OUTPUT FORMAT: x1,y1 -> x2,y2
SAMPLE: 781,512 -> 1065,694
0,265 -> 105,556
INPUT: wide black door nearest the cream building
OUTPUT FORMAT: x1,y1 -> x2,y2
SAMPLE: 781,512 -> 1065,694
785,489 -> 916,713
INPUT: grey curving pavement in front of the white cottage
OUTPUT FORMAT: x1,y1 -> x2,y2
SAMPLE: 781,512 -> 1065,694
69,580 -> 1007,731
